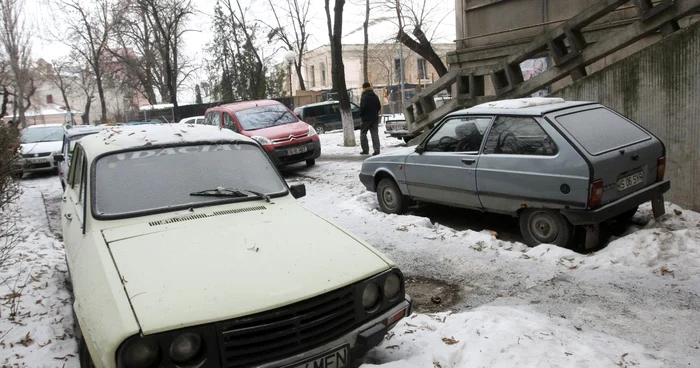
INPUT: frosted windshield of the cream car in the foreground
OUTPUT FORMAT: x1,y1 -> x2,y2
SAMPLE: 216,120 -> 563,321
92,143 -> 287,218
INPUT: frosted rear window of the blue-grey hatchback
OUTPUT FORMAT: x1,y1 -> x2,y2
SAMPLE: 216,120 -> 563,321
556,107 -> 650,156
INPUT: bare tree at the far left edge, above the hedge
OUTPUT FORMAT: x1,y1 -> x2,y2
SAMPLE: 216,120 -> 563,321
0,0 -> 35,126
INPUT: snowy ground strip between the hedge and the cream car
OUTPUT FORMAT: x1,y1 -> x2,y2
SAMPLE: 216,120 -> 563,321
0,177 -> 78,368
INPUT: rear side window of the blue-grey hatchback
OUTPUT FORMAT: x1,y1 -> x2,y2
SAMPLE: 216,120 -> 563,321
484,116 -> 559,156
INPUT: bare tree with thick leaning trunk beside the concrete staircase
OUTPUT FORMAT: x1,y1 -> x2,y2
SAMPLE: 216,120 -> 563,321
385,0 -> 447,77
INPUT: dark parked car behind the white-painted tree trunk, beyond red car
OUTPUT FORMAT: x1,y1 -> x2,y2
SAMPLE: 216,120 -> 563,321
294,101 -> 362,134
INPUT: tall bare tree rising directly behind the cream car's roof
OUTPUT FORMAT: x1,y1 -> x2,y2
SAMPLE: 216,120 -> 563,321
138,0 -> 194,120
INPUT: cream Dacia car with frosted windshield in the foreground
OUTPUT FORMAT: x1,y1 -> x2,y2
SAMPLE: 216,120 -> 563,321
61,125 -> 412,368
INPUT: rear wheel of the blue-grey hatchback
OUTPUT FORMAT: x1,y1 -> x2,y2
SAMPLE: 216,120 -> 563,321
520,209 -> 574,247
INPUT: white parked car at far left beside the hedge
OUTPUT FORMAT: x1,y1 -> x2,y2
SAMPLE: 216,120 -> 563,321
14,124 -> 63,177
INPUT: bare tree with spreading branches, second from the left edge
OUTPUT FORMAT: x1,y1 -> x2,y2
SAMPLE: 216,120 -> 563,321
54,0 -> 123,124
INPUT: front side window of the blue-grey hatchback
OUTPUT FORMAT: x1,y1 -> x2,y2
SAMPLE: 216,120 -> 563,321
425,117 -> 491,152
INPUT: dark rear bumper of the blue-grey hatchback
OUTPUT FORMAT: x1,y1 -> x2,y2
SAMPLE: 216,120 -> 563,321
561,180 -> 671,226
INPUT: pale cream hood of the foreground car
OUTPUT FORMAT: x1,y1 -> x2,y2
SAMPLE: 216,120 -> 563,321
103,198 -> 391,334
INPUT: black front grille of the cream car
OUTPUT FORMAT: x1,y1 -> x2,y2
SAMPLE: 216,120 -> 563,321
216,287 -> 358,368
